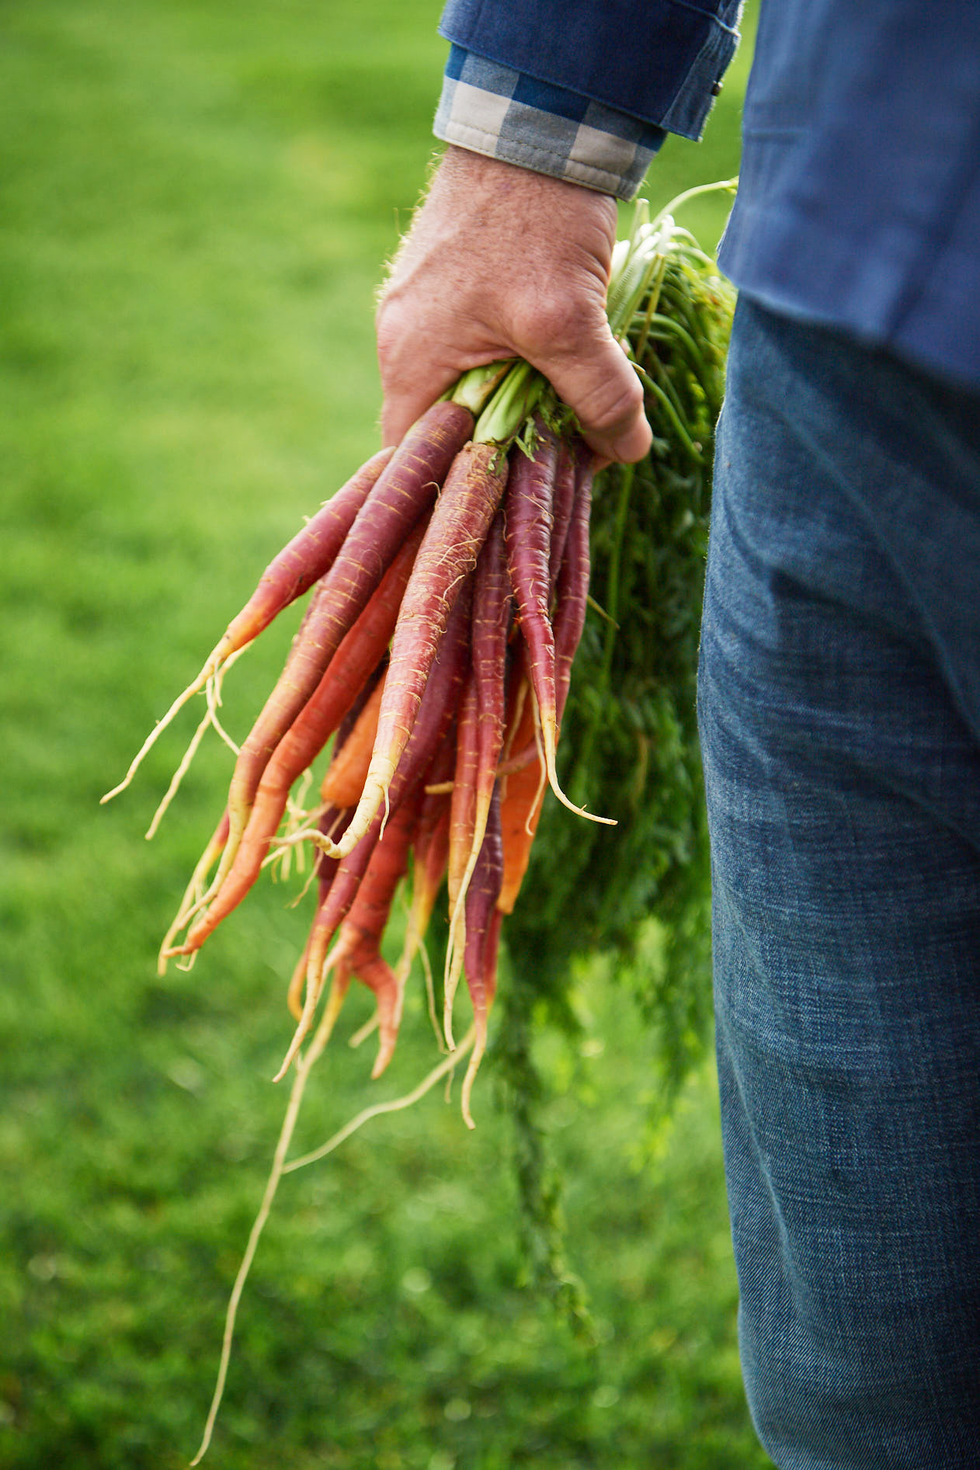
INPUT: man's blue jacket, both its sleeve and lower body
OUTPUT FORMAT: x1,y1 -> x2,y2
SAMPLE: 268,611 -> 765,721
441,0 -> 980,387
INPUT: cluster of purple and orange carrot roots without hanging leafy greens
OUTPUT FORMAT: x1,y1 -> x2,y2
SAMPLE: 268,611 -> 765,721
110,346 -> 614,1126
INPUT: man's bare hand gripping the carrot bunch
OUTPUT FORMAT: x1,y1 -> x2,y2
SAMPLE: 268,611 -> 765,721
378,147 -> 651,462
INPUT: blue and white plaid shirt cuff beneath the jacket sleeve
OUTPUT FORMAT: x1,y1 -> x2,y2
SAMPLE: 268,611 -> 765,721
433,46 -> 664,200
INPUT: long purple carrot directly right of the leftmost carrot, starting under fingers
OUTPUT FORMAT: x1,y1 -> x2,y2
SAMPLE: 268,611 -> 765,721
228,403 -> 473,870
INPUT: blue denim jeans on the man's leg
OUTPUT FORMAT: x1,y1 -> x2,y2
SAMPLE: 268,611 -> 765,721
699,300 -> 980,1470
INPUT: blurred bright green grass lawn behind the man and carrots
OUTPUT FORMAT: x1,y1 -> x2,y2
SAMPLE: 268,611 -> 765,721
0,0 -> 768,1470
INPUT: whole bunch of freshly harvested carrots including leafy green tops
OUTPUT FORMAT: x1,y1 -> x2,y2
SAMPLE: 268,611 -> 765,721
106,183 -> 732,1458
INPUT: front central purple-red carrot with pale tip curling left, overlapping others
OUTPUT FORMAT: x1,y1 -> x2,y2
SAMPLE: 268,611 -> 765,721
338,444 -> 514,854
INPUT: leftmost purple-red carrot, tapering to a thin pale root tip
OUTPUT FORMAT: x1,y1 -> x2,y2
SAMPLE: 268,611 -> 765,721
101,448 -> 394,803
